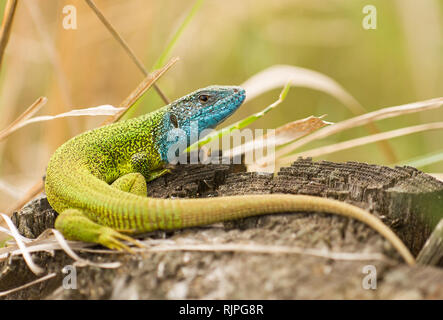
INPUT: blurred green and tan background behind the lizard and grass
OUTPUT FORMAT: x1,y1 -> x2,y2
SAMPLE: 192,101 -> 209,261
0,0 -> 443,210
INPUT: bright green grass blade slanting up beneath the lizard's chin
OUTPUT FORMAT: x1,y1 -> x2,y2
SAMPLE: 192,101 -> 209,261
186,82 -> 291,152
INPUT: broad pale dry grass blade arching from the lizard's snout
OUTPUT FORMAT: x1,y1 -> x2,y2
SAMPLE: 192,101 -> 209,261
242,65 -> 397,162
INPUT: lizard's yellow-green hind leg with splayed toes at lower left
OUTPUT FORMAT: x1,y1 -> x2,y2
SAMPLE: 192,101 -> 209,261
55,209 -> 143,253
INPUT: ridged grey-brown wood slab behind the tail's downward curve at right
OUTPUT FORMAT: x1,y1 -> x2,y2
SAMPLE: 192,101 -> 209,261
273,159 -> 443,254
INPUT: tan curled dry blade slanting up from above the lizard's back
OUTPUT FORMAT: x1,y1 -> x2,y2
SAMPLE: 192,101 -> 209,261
103,57 -> 179,125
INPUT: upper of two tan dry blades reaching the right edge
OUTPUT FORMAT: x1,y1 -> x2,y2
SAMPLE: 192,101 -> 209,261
276,98 -> 443,158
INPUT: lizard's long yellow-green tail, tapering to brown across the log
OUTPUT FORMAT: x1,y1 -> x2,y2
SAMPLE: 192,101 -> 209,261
52,174 -> 415,264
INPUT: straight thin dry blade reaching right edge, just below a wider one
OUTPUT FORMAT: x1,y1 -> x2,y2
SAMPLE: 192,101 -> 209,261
277,122 -> 443,166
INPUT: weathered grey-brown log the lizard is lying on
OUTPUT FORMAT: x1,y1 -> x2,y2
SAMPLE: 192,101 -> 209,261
0,159 -> 443,299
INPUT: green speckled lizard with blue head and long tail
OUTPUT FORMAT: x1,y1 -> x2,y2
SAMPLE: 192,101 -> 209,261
45,86 -> 415,264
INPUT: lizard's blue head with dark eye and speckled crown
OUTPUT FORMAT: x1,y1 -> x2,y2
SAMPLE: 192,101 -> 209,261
159,86 -> 246,161
